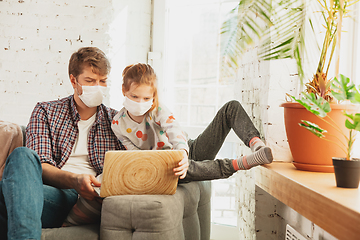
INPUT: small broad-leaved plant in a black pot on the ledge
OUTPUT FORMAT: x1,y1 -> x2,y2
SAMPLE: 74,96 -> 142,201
292,75 -> 360,188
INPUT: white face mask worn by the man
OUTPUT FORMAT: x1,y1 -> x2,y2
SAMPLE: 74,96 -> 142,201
76,83 -> 106,108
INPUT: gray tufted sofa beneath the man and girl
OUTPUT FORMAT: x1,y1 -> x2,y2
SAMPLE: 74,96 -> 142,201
1,123 -> 211,240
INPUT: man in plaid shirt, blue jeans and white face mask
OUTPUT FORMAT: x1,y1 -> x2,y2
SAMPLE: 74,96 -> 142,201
0,47 -> 190,239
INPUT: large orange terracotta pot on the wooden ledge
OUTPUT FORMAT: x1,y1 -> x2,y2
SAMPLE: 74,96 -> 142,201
280,102 -> 358,172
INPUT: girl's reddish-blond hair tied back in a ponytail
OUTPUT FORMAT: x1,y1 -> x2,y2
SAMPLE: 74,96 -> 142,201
122,63 -> 159,112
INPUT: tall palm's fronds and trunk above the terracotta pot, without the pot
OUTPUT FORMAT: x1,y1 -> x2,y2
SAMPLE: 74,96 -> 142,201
222,0 -> 359,99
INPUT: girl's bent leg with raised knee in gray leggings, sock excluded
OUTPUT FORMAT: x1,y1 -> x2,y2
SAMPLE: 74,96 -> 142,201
188,100 -> 260,161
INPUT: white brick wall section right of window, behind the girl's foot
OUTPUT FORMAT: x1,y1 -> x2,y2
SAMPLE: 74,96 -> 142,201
235,45 -> 298,240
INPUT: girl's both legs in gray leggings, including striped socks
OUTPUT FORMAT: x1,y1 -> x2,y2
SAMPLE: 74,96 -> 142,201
184,101 -> 272,182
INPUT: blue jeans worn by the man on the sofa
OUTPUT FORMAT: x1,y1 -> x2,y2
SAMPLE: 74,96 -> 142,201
0,147 -> 78,240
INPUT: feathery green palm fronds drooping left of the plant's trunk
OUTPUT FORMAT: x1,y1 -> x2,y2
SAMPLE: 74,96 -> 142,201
221,0 -> 305,81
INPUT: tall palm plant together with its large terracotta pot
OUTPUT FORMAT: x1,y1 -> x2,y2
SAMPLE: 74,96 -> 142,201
224,0 -> 358,172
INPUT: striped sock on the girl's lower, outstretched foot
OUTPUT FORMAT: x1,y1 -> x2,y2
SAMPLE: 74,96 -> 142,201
233,147 -> 273,171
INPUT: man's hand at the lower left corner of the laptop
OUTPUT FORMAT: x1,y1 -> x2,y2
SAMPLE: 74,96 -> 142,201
74,174 -> 101,200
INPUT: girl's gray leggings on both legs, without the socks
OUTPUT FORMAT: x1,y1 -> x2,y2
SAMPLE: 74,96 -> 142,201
179,100 -> 260,182
